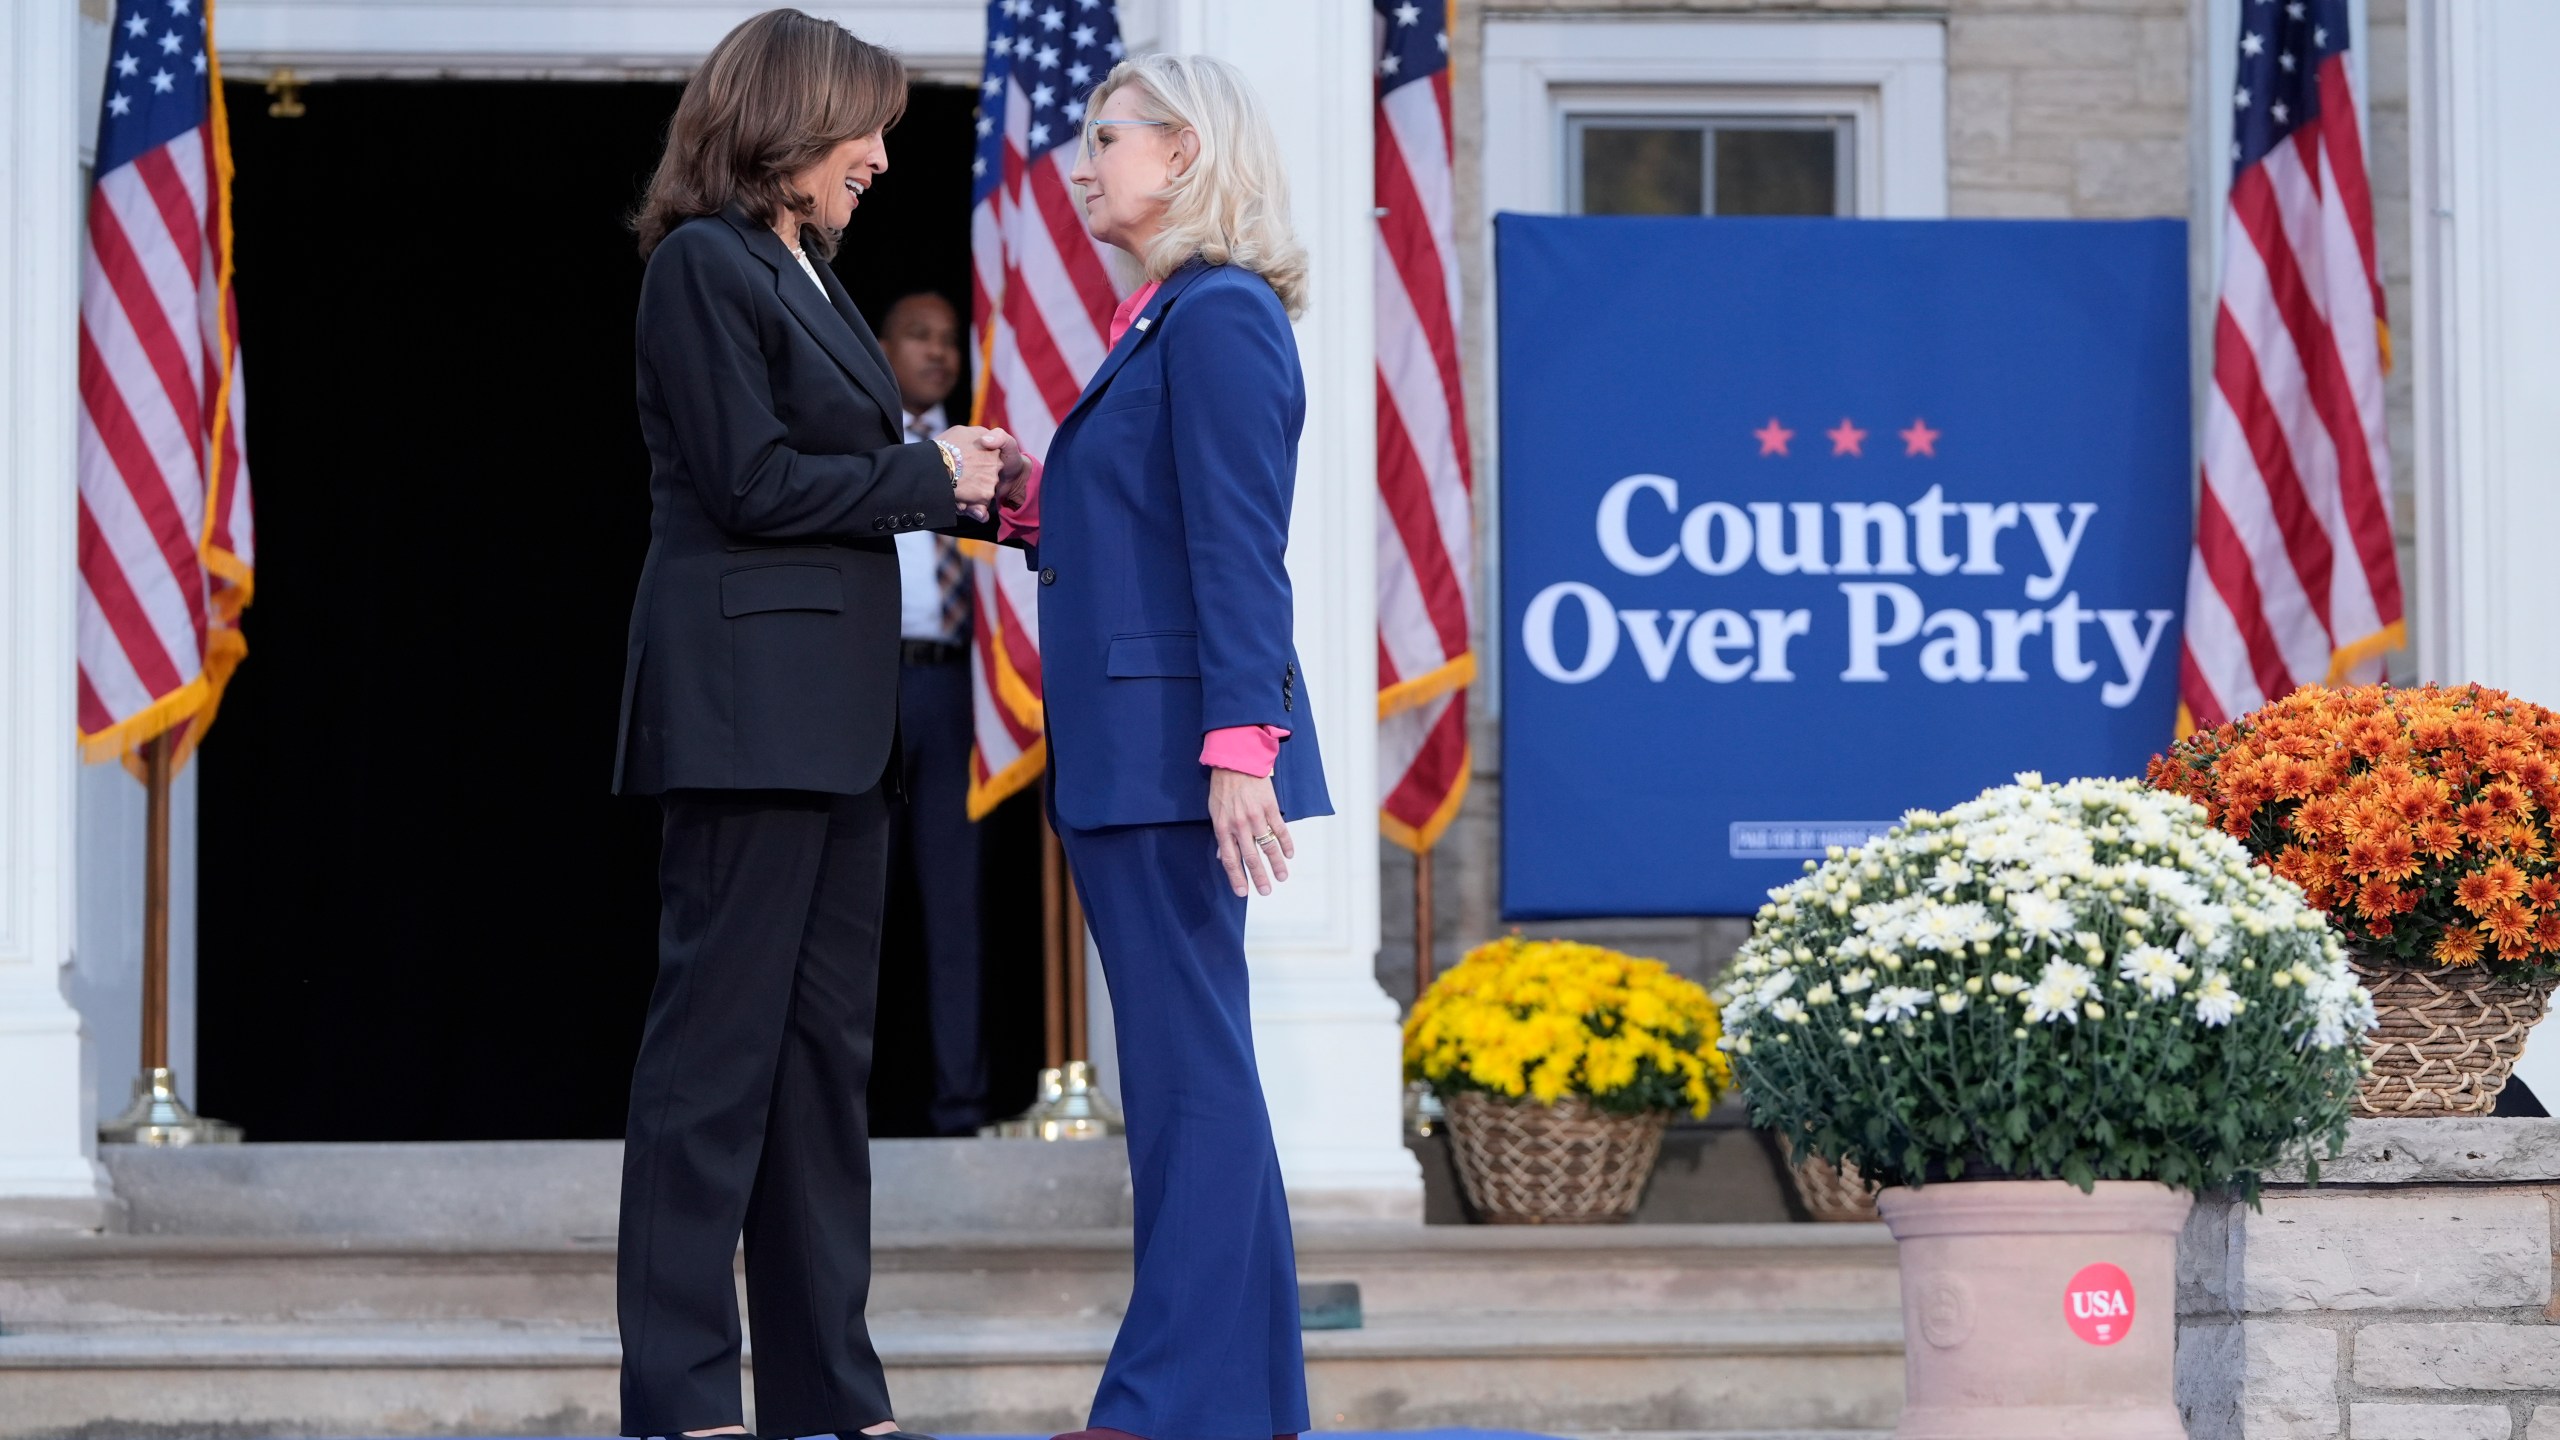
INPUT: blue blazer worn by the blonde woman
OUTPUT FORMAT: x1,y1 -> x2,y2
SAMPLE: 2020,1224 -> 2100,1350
1027,261 -> 1334,830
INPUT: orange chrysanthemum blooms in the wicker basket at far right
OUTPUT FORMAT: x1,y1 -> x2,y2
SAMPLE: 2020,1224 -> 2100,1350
2150,684 -> 2560,969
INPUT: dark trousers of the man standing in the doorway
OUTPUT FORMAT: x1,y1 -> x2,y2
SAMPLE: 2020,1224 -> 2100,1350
888,651 -> 988,1135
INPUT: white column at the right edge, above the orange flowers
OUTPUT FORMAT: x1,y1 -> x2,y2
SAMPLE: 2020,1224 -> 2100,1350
2409,0 -> 2560,1107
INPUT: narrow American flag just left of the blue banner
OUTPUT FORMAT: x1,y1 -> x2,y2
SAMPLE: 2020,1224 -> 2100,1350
1375,0 -> 1475,851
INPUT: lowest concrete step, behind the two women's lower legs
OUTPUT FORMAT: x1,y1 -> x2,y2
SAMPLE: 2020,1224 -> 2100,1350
0,1312 -> 1902,1440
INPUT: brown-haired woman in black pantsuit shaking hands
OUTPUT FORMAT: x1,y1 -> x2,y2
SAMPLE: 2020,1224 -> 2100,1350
614,10 -> 1004,1437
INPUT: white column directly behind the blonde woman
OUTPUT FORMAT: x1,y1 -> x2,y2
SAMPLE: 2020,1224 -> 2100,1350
1141,0 -> 1421,1220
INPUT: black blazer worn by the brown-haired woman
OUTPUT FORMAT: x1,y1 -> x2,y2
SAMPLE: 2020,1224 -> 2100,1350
614,205 -> 993,794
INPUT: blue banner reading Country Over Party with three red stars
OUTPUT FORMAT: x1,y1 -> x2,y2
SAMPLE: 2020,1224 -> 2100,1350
1495,215 -> 2191,917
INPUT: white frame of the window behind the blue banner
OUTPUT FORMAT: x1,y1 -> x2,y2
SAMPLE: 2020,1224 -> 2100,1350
1475,15 -> 1946,715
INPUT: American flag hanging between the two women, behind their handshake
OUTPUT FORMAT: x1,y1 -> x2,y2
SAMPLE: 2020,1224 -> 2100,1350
968,0 -> 1126,817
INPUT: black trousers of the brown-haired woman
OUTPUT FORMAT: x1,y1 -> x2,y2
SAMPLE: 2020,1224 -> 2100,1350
620,787 -> 891,1435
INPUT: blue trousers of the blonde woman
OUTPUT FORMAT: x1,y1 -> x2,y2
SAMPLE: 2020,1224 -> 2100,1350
1060,822 -> 1308,1440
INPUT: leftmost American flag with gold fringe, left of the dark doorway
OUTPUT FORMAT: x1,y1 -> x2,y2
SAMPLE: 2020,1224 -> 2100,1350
79,0 -> 253,758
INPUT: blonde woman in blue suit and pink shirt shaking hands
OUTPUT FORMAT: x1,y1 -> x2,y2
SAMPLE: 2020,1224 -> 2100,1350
1004,56 -> 1331,1440
